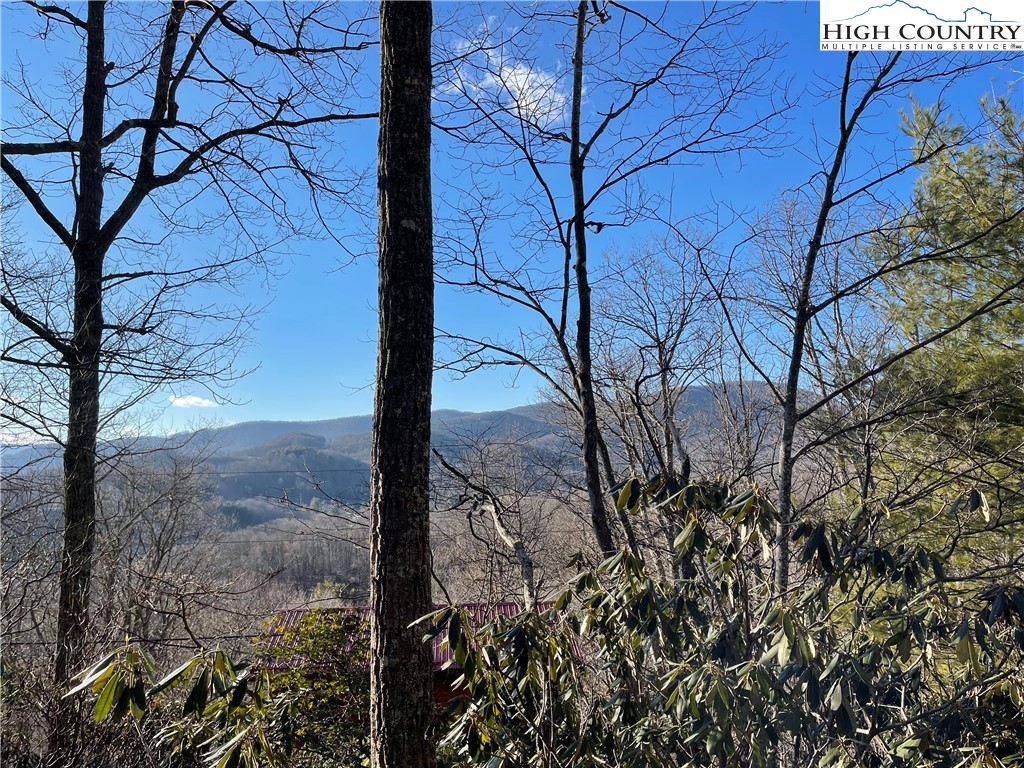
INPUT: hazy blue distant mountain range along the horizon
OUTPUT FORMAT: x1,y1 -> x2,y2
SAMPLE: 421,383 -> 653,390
0,387 -> 770,525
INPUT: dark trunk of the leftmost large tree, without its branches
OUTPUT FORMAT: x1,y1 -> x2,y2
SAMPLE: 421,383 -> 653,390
50,2 -> 106,764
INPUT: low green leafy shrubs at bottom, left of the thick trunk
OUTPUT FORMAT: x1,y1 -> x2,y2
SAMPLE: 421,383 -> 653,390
68,610 -> 370,768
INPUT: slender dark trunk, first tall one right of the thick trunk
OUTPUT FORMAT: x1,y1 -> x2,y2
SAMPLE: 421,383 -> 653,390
569,0 -> 610,555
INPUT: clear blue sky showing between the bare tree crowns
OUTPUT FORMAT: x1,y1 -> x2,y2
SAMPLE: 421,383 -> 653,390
2,2 -> 1024,431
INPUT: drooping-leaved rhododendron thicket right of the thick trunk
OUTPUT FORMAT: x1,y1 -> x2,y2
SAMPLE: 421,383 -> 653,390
438,479 -> 1024,768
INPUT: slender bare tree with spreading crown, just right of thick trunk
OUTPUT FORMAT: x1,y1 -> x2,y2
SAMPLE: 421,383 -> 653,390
439,2 -> 784,553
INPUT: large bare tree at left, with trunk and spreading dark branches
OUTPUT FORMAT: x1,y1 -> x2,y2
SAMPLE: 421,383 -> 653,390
0,0 -> 371,746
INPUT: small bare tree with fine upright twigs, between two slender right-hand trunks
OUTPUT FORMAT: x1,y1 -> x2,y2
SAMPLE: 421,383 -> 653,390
594,239 -> 721,573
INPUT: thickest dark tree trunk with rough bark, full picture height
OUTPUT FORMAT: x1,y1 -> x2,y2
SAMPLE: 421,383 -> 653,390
370,0 -> 434,768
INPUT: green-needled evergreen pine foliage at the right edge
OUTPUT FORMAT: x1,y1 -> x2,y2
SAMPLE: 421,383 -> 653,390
872,98 -> 1024,530
